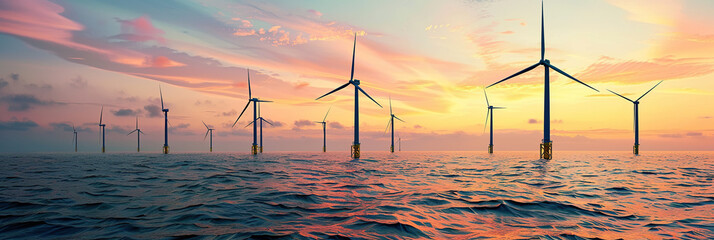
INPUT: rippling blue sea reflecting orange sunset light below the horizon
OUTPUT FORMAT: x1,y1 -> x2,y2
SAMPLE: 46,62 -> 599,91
0,152 -> 714,239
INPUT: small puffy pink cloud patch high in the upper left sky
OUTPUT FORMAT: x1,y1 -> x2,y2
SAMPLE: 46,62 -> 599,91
112,16 -> 166,44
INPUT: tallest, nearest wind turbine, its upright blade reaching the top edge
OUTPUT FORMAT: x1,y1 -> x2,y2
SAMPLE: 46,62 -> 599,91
486,1 -> 600,159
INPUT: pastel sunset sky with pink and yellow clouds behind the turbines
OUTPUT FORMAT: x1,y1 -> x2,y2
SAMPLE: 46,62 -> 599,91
0,0 -> 714,152
